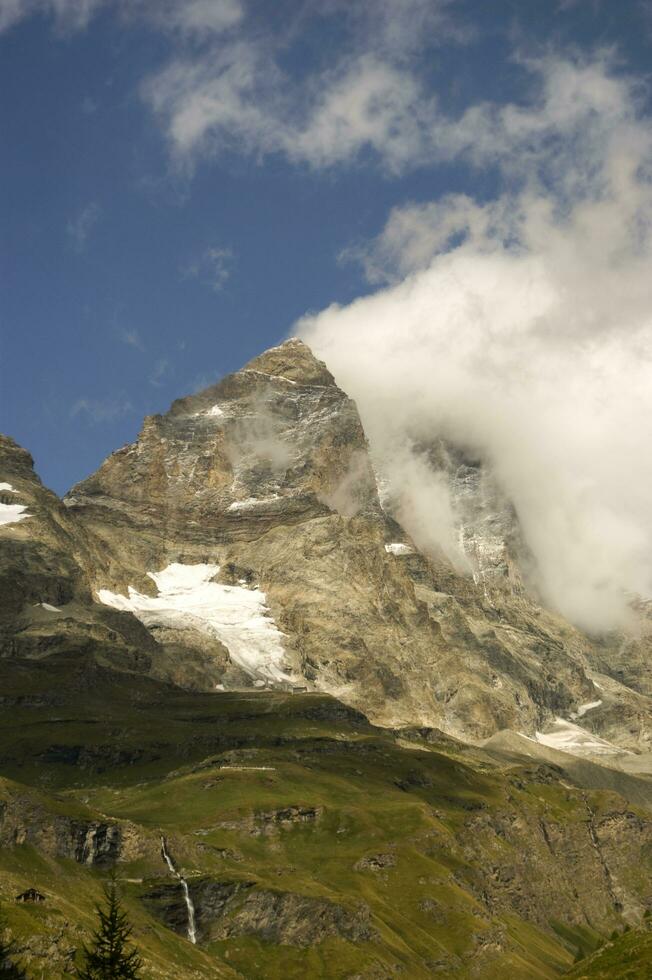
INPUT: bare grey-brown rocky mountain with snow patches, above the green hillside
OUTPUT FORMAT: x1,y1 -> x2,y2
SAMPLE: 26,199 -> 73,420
0,340 -> 651,751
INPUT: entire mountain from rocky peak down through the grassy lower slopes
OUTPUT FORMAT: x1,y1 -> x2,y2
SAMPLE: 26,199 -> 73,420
0,339 -> 652,980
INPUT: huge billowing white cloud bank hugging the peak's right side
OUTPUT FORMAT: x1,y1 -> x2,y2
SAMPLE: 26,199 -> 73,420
295,59 -> 652,630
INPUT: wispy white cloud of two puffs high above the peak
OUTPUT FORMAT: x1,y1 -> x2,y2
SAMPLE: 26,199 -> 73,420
143,42 -> 444,172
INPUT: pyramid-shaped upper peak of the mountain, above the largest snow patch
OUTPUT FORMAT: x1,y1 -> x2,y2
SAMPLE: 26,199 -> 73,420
66,341 -> 380,585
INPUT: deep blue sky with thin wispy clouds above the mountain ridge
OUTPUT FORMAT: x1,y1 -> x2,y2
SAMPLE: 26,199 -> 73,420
0,0 -> 652,492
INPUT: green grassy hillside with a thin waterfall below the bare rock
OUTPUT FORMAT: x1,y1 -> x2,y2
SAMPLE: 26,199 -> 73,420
0,655 -> 652,980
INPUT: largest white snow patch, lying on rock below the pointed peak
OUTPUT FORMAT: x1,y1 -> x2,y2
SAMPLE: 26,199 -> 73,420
98,562 -> 291,683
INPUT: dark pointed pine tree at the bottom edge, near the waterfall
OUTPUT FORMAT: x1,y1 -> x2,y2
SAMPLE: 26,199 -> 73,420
76,876 -> 142,980
